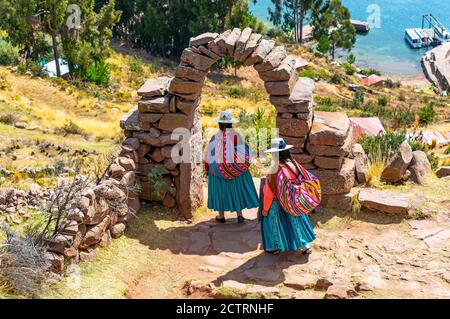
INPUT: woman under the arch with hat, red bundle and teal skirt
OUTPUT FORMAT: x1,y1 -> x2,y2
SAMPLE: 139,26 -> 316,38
205,112 -> 259,223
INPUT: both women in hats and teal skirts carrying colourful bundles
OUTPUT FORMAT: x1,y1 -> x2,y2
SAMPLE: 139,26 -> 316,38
205,112 -> 320,254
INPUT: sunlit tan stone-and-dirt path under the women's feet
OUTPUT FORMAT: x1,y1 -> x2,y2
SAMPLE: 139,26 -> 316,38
127,195 -> 450,298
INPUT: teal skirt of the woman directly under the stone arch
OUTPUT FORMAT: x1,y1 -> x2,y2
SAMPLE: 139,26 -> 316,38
208,169 -> 259,212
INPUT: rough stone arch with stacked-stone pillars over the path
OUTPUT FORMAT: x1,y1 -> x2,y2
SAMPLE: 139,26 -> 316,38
121,28 -> 354,218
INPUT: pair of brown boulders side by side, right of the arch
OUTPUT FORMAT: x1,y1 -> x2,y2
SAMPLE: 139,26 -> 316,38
381,141 -> 432,184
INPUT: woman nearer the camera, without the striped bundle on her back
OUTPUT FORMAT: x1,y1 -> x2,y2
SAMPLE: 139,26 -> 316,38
261,138 -> 316,254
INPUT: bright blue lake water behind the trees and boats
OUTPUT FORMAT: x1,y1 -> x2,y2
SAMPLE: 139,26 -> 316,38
249,0 -> 450,76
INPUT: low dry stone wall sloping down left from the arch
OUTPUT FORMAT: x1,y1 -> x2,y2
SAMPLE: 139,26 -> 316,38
47,143 -> 141,273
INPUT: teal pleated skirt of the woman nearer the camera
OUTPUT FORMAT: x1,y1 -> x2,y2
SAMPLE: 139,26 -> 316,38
261,199 -> 316,252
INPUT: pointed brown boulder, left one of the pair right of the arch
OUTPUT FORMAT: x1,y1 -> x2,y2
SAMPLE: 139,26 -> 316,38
381,141 -> 413,183
